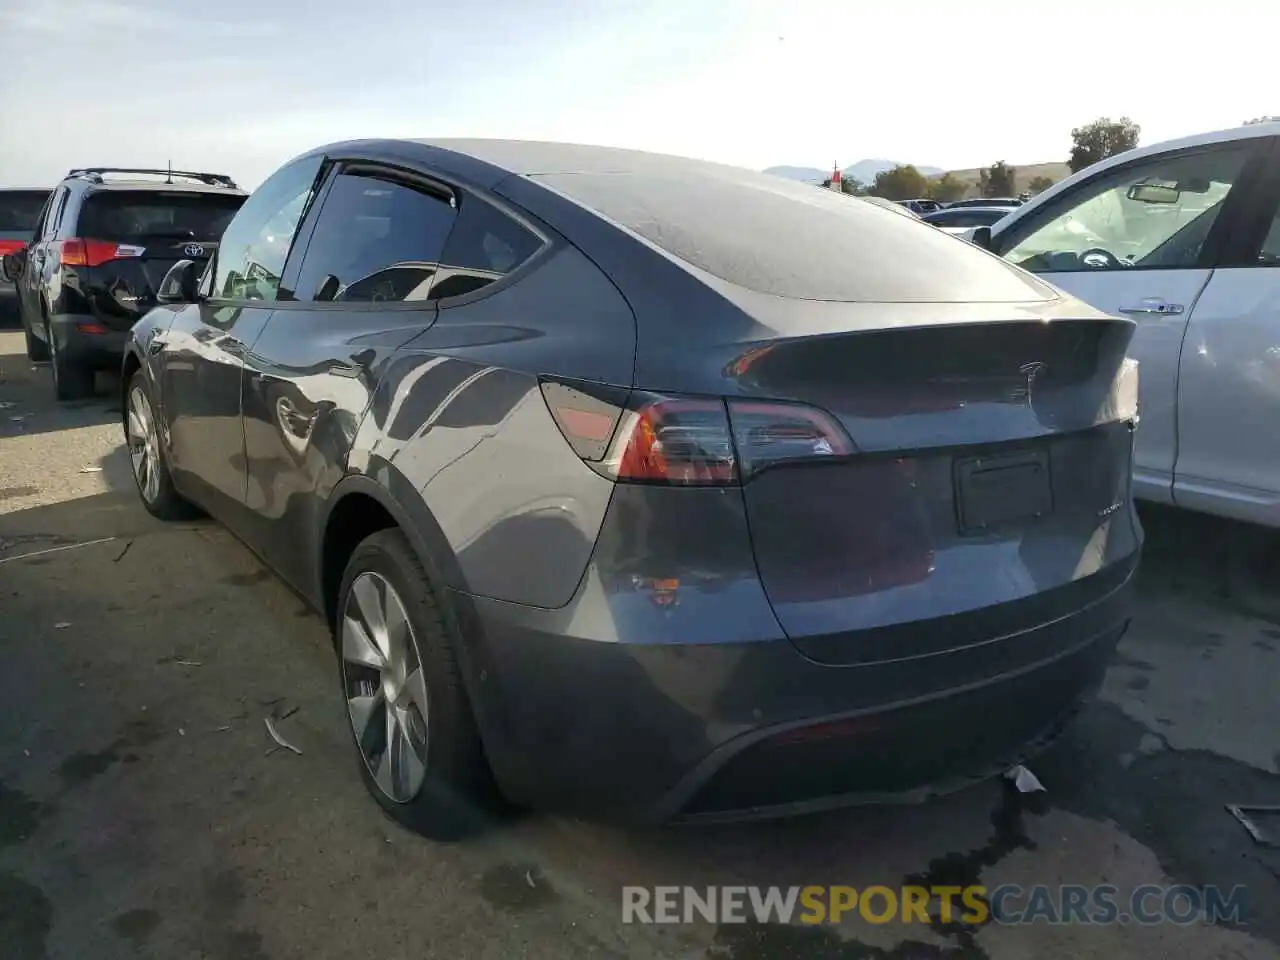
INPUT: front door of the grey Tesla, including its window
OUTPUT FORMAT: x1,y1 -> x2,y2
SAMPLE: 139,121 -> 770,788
160,157 -> 321,529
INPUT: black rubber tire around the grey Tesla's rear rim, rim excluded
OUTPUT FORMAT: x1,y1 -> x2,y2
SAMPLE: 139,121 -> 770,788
334,529 -> 509,841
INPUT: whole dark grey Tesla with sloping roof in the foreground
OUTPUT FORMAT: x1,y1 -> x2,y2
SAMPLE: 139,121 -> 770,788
123,141 -> 1142,837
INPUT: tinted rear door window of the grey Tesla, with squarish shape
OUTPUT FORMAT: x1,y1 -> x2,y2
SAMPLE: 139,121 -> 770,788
296,173 -> 457,303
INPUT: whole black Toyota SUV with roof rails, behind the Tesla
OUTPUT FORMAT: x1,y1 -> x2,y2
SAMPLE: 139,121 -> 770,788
4,168 -> 247,399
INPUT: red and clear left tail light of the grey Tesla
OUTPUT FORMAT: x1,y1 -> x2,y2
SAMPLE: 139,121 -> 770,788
543,381 -> 854,486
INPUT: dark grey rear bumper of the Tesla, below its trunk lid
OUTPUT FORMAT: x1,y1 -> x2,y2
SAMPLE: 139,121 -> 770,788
454,553 -> 1138,822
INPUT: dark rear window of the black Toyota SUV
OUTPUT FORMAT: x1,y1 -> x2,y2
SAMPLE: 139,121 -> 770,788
77,191 -> 244,242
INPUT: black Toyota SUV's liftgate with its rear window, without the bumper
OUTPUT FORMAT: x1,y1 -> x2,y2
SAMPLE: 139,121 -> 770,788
76,187 -> 244,330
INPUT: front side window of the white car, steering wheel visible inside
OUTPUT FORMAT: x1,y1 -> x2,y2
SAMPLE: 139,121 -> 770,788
1005,145 -> 1252,273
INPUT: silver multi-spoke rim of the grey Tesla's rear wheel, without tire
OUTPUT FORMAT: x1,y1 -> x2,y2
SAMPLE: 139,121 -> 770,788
340,572 -> 428,804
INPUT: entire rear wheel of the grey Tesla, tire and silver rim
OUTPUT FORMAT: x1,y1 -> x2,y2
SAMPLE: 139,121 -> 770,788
334,530 -> 503,840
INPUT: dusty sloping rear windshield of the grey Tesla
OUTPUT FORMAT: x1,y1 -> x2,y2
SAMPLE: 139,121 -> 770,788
534,168 -> 1053,302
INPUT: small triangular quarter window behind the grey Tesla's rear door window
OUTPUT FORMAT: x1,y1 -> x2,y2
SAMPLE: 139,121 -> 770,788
430,196 -> 543,300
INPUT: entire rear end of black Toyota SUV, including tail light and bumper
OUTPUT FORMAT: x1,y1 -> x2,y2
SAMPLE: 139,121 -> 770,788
51,183 -> 246,367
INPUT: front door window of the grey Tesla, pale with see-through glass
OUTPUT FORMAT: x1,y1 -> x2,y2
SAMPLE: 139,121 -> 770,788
214,156 -> 321,302
